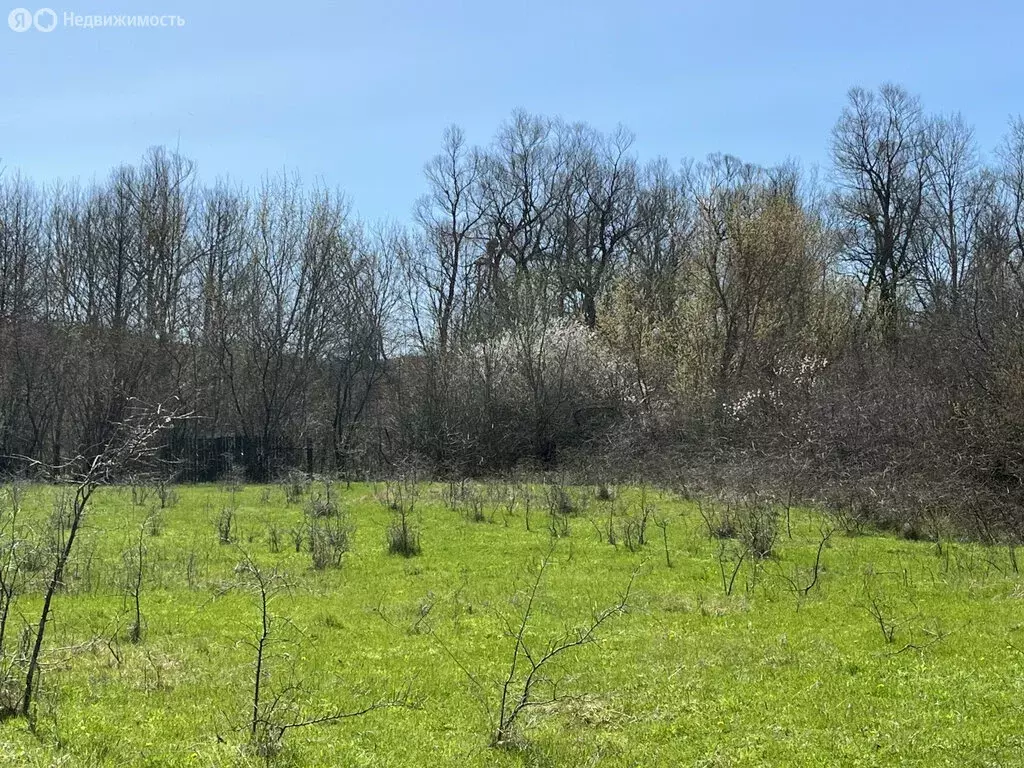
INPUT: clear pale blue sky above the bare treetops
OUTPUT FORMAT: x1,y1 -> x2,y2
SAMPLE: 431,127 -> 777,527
0,0 -> 1024,219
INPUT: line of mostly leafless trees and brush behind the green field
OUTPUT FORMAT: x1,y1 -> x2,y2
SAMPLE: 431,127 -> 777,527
0,84 -> 1024,525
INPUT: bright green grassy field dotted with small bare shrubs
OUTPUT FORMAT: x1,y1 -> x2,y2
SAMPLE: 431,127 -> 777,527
0,484 -> 1024,768
